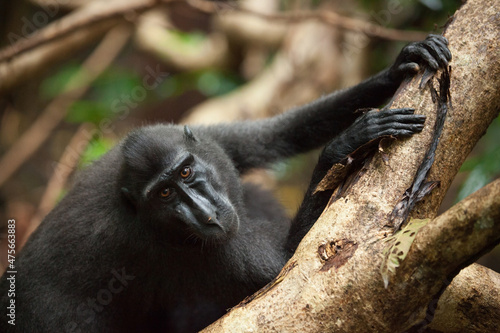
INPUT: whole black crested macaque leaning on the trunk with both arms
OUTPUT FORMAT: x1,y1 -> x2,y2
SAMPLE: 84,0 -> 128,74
0,35 -> 451,332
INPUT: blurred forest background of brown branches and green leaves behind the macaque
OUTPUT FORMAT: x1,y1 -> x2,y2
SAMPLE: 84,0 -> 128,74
0,0 -> 500,272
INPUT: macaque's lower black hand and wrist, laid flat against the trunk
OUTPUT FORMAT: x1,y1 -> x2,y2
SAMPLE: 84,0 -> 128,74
318,108 -> 425,172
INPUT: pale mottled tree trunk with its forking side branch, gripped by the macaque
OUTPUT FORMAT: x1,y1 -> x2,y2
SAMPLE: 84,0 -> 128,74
205,0 -> 500,332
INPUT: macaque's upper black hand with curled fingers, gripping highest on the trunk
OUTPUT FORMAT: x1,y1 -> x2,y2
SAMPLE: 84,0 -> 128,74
388,35 -> 451,84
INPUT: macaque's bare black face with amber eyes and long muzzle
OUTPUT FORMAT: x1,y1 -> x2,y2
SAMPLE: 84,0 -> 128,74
143,151 -> 239,240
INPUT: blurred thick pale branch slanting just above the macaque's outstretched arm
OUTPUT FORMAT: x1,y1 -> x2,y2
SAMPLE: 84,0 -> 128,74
183,22 -> 341,124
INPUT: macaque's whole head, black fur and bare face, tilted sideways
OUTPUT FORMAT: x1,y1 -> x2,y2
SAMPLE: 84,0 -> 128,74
120,125 -> 242,244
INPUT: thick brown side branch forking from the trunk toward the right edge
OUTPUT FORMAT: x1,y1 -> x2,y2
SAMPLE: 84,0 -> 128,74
405,179 -> 500,276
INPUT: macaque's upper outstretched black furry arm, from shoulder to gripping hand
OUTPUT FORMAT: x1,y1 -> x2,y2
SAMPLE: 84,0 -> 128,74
198,35 -> 451,172
